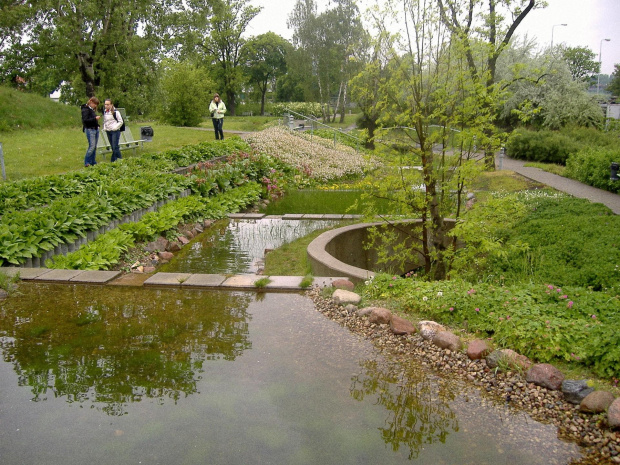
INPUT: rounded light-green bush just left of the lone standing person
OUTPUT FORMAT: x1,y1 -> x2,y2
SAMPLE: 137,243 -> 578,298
160,61 -> 215,126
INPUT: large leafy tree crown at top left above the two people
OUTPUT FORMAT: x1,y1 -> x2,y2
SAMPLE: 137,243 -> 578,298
2,0 -> 169,112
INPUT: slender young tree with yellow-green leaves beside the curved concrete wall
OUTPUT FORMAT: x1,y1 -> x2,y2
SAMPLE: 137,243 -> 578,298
360,0 -> 499,279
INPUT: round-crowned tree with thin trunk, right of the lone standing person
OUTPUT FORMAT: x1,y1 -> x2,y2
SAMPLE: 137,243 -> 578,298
243,32 -> 291,115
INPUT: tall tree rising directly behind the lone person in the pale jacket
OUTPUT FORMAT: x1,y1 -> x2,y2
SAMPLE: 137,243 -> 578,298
200,0 -> 261,115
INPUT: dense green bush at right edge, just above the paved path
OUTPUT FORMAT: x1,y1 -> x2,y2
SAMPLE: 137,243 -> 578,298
566,147 -> 620,192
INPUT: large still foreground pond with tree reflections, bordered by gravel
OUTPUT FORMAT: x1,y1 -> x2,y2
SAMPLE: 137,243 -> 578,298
0,283 -> 579,465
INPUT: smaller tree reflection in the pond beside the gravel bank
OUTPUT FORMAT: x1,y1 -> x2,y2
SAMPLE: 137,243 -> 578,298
351,360 -> 458,460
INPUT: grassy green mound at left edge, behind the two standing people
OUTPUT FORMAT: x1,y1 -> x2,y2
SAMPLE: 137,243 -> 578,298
0,86 -> 82,131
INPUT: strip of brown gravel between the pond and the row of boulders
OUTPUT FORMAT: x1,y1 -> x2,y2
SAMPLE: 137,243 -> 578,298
308,289 -> 620,465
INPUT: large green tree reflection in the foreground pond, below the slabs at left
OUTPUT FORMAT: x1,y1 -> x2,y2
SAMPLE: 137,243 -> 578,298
0,285 -> 252,415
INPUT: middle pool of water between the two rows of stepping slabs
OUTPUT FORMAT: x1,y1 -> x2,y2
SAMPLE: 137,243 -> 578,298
161,218 -> 341,274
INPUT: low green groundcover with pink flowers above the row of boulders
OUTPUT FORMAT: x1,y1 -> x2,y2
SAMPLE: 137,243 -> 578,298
363,274 -> 620,377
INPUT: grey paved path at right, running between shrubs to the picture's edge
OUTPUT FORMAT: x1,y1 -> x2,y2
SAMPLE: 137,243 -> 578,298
495,157 -> 620,215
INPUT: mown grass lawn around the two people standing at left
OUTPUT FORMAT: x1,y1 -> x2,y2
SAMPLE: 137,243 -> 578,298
0,123 -> 214,181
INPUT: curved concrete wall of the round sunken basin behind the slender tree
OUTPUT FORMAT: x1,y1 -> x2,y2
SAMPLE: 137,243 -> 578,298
307,219 -> 454,282
